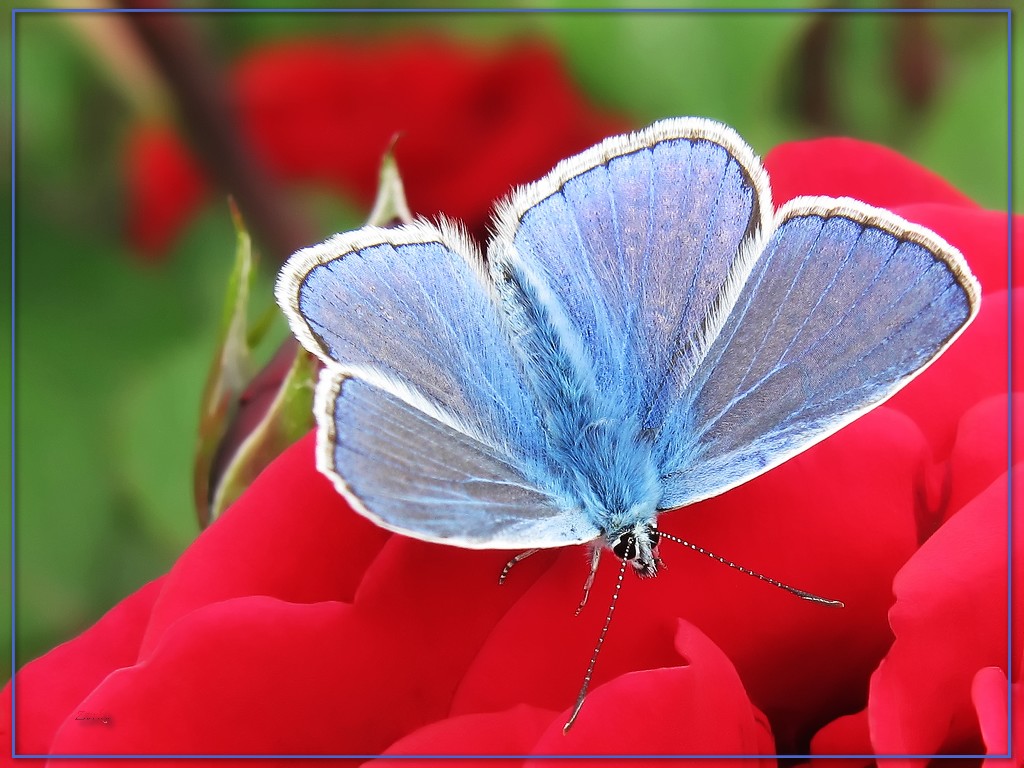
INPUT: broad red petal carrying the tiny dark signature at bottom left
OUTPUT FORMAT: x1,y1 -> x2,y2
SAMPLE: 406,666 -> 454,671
46,540 -> 561,755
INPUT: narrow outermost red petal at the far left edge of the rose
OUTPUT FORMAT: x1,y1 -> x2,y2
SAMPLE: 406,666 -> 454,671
0,579 -> 163,755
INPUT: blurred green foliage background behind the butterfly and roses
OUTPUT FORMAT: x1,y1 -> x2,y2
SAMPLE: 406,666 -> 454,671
8,11 -> 1021,679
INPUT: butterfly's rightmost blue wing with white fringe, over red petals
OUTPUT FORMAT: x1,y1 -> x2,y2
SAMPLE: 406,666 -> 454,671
656,198 -> 980,509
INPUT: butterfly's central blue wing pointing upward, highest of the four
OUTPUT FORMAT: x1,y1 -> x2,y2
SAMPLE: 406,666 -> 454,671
487,118 -> 771,418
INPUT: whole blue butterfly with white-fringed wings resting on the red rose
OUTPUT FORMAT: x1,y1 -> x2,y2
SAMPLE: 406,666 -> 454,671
276,118 -> 980,727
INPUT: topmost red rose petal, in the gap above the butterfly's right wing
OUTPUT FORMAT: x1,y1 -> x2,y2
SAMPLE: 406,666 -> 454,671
765,138 -> 977,208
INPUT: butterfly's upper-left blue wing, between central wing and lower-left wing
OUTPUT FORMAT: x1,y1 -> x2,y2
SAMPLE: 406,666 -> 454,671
280,223 -> 524,453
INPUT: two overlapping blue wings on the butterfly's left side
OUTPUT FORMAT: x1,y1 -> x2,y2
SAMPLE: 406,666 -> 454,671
276,222 -> 598,547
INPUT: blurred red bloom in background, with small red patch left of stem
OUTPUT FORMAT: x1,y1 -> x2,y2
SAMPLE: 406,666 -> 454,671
126,37 -> 628,258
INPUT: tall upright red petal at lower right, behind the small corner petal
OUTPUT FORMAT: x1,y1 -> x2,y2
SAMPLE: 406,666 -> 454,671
868,467 -> 1024,754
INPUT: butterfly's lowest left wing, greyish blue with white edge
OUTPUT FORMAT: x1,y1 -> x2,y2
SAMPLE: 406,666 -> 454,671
316,367 -> 599,549
